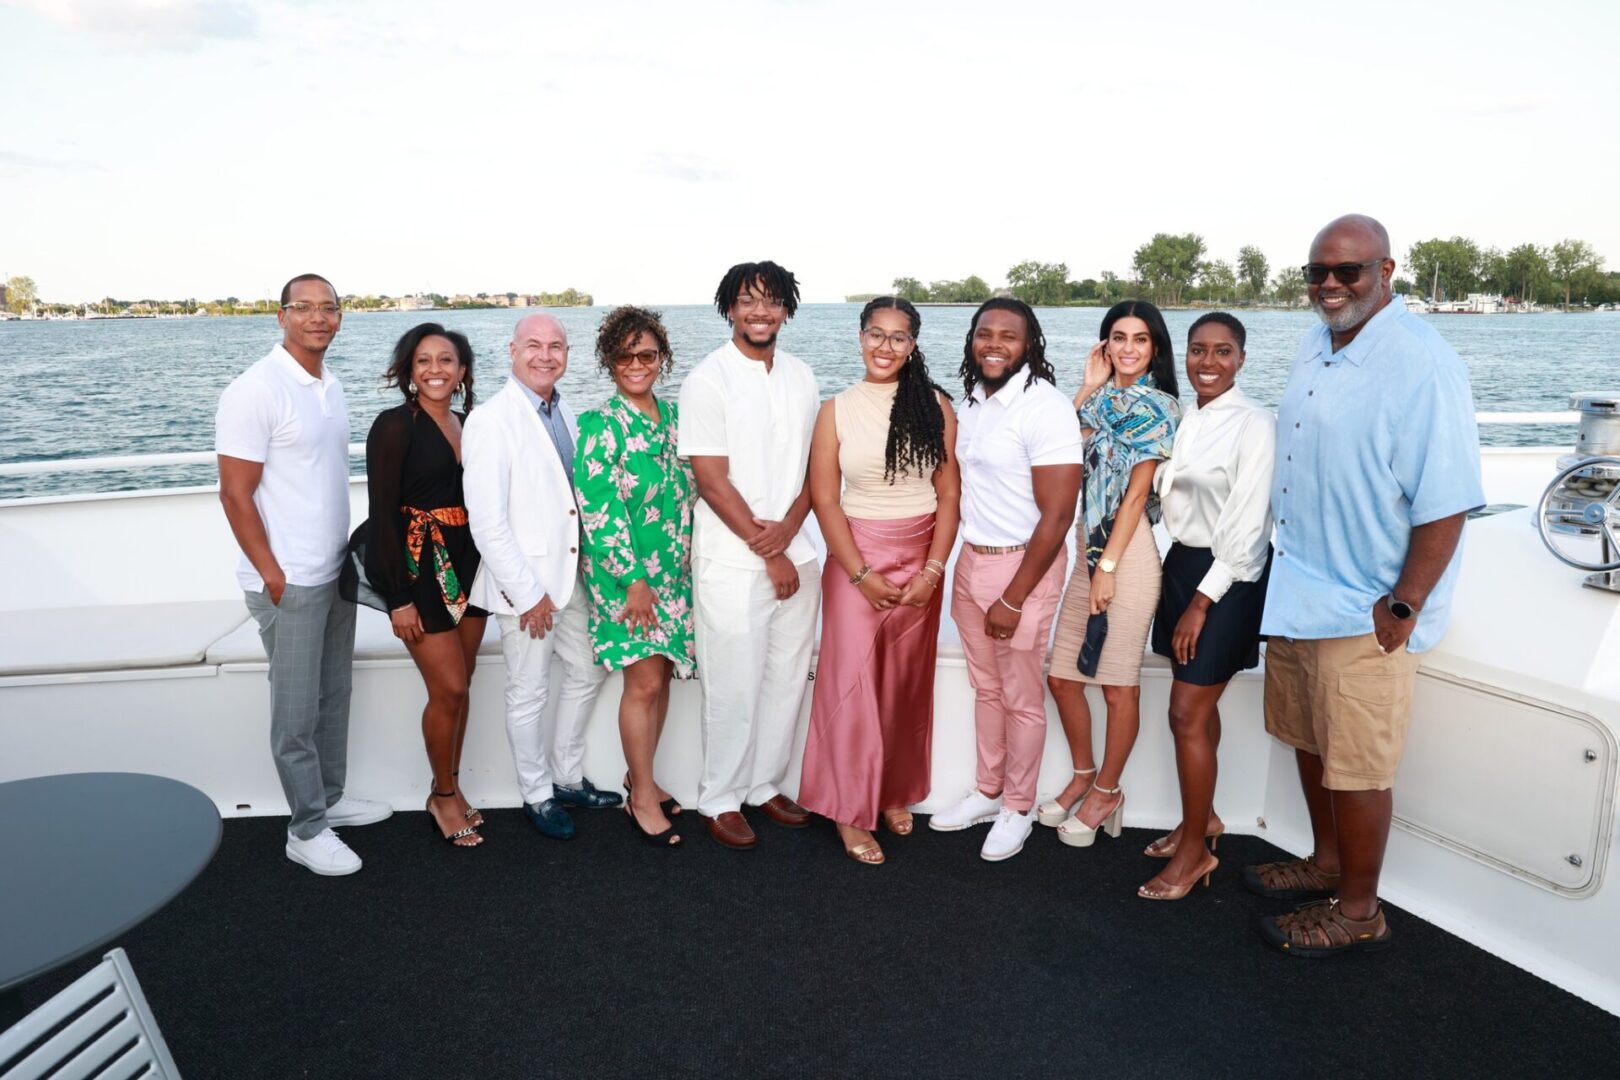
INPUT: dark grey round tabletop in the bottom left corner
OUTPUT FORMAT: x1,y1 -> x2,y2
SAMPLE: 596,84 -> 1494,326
0,772 -> 220,1014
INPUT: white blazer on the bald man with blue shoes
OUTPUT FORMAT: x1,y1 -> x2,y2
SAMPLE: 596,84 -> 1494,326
462,379 -> 580,615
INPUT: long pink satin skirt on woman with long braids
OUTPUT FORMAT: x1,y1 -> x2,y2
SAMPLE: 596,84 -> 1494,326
799,513 -> 943,829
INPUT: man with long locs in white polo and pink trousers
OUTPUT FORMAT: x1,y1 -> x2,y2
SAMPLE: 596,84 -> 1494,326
928,298 -> 1084,861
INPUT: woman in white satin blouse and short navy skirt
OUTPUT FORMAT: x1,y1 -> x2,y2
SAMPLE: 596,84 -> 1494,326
1137,311 -> 1277,900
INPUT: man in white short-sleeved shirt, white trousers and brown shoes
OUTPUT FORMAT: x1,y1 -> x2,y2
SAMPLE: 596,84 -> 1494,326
679,262 -> 821,848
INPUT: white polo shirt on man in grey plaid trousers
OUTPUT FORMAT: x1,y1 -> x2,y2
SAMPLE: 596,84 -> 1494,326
214,345 -> 348,593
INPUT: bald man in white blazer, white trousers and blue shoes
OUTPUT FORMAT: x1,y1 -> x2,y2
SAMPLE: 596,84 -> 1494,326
462,307 -> 620,840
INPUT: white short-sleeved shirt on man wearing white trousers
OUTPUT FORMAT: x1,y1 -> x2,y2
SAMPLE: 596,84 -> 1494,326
677,342 -> 820,570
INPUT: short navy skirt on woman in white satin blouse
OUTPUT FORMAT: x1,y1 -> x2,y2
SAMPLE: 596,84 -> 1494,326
1153,544 -> 1272,687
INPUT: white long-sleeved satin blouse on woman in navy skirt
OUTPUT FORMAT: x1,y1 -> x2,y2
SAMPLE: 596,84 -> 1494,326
1153,387 -> 1277,601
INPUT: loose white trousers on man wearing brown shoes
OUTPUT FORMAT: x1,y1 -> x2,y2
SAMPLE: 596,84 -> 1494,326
692,559 -> 821,818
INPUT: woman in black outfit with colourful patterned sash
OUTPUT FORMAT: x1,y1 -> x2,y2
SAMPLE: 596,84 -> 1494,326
366,322 -> 489,847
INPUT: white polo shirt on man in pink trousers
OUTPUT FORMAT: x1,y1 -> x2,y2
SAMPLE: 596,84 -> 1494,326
956,371 -> 1085,547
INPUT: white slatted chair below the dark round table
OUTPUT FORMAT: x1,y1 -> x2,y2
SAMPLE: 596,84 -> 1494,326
0,949 -> 180,1080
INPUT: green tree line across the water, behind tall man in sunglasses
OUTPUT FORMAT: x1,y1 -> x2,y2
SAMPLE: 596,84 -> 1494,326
851,233 -> 1620,308
